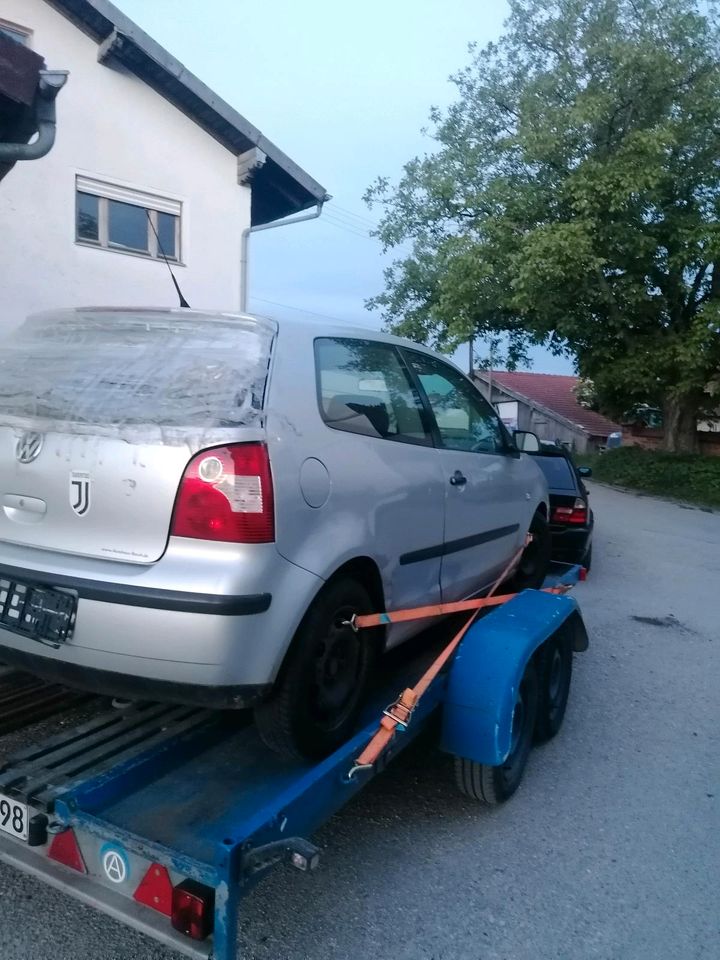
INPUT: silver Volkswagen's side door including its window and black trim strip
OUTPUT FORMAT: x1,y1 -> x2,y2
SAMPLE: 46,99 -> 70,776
406,350 -> 530,601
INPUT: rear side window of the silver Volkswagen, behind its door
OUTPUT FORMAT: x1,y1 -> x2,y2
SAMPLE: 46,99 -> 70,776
315,337 -> 432,446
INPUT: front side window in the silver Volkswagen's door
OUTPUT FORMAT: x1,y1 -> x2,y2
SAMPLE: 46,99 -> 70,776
406,351 -> 508,453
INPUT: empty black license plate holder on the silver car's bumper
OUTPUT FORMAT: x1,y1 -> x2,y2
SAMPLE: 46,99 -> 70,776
0,579 -> 77,647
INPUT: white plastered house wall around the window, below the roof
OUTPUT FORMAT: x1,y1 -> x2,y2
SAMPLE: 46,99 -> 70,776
0,0 -> 250,331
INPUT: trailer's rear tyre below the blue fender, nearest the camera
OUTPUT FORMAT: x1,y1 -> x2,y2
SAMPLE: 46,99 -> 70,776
455,663 -> 538,806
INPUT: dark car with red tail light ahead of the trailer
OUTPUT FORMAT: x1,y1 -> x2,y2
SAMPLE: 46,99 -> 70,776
532,443 -> 594,570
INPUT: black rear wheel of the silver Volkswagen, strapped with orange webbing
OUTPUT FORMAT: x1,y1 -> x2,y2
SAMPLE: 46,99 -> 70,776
255,579 -> 378,760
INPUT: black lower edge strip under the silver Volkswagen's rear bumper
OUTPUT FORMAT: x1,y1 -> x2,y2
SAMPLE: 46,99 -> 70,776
0,646 -> 272,710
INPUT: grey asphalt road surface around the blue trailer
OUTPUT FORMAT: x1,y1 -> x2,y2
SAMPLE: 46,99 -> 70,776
0,486 -> 720,960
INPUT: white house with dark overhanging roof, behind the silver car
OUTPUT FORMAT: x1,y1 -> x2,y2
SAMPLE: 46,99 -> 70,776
0,0 -> 326,330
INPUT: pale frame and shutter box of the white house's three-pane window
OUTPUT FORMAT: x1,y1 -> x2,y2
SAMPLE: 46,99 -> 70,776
75,174 -> 183,266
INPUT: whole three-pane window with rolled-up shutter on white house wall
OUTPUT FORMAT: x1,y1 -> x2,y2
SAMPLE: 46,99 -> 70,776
75,177 -> 182,263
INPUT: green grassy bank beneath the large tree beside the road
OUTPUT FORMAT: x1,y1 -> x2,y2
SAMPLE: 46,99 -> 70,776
575,447 -> 720,507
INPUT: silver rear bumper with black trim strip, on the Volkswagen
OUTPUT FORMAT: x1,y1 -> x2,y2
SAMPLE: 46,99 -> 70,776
0,541 -> 323,688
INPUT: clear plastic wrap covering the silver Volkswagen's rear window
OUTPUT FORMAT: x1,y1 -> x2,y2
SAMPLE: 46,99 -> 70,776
0,309 -> 275,443
